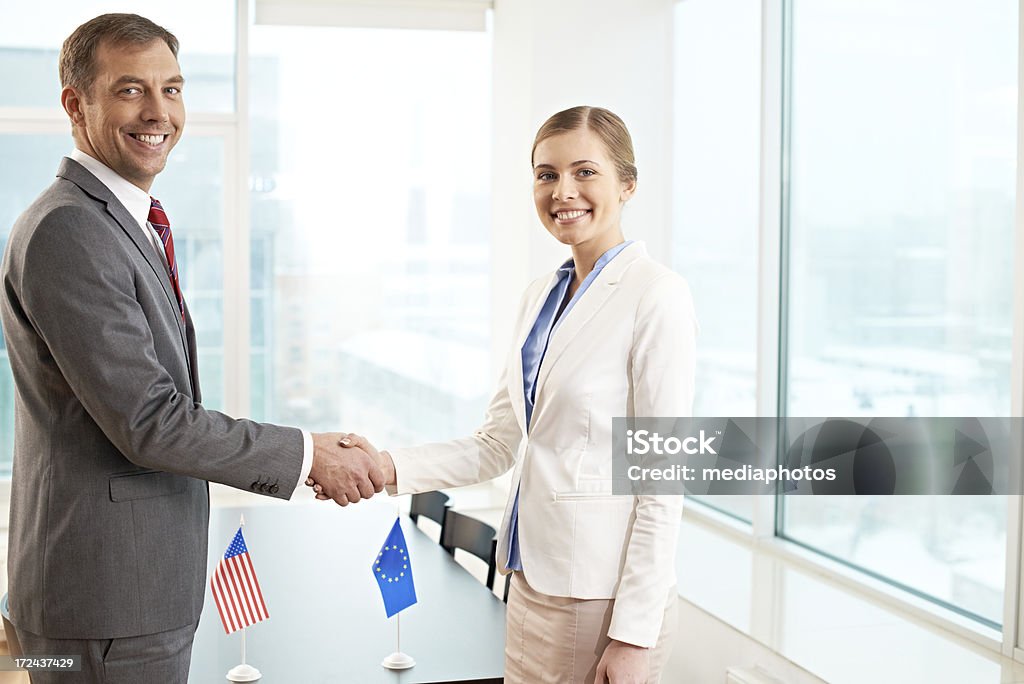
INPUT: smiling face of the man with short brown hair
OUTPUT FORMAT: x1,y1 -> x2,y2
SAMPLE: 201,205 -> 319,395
61,40 -> 185,193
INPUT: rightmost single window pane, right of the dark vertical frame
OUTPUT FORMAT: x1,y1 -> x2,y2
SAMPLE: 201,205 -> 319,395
782,0 -> 1017,625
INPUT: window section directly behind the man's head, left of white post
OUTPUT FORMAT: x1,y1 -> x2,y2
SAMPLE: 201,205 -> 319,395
0,5 -> 234,456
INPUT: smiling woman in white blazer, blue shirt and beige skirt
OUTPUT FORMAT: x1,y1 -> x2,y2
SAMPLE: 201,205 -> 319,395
335,106 -> 696,684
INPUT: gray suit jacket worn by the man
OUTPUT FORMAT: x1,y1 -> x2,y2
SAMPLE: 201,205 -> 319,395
0,159 -> 303,639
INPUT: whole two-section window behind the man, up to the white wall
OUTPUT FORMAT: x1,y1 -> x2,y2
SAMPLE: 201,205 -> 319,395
0,0 -> 492,474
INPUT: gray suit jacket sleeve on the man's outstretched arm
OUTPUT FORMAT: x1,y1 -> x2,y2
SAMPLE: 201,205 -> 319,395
17,206 -> 303,499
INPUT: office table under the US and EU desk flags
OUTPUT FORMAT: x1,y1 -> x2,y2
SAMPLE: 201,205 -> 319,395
188,499 -> 505,684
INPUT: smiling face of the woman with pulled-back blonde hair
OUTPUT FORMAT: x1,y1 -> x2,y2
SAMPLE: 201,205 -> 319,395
534,128 -> 636,256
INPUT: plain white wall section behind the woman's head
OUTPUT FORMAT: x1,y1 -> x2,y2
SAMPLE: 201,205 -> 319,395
492,0 -> 674,375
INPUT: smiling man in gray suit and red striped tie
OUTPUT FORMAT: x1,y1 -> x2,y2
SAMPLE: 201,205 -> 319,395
0,14 -> 383,684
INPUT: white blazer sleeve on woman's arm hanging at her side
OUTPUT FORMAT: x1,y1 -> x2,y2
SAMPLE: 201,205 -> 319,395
608,273 -> 697,647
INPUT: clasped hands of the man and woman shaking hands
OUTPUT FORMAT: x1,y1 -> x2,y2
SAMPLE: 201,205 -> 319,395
306,432 -> 395,506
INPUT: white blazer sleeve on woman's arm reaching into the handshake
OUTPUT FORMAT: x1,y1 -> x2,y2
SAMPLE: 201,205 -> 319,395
389,281 -> 544,494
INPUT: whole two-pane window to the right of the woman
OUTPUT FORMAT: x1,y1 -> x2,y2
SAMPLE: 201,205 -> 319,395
673,0 -> 1018,627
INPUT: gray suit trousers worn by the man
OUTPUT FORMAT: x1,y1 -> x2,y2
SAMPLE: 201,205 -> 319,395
14,623 -> 199,684
